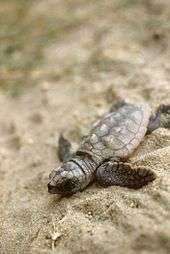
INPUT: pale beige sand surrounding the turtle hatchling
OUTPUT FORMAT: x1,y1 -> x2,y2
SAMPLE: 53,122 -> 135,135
0,0 -> 170,254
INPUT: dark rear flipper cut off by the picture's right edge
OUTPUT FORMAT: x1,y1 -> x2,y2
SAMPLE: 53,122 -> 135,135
147,105 -> 170,134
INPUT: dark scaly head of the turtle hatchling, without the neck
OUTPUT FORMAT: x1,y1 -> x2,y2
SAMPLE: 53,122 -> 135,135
48,161 -> 82,196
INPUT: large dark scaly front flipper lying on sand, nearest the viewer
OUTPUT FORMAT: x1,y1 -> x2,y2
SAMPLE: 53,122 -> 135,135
96,161 -> 156,189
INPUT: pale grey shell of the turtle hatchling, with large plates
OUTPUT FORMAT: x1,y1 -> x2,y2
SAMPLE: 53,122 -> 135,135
79,103 -> 151,162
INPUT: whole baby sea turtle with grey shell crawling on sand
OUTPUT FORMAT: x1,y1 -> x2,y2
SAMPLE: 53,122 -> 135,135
48,101 -> 170,196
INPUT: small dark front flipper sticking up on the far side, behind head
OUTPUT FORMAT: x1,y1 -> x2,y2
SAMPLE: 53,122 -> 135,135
58,134 -> 72,162
